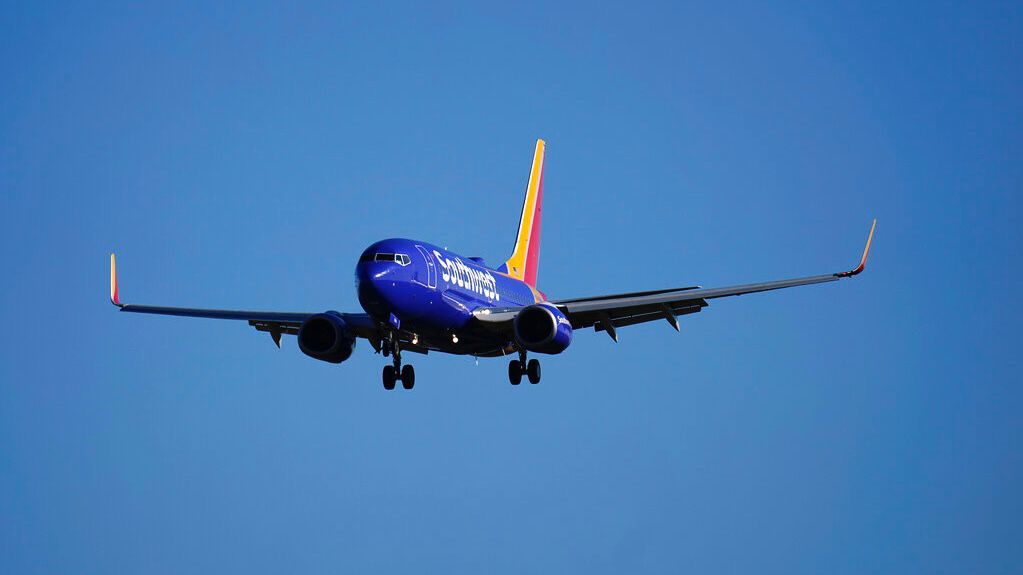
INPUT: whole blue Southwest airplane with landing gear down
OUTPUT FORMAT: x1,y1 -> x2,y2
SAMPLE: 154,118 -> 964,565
110,140 -> 877,390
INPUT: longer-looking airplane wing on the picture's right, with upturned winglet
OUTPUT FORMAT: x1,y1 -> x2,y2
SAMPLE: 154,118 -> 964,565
474,220 -> 878,342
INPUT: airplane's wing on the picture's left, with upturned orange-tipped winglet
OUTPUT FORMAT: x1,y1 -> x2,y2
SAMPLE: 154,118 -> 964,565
110,254 -> 380,347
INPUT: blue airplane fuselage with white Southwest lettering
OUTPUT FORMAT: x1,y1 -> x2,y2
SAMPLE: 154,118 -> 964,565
355,238 -> 545,355
